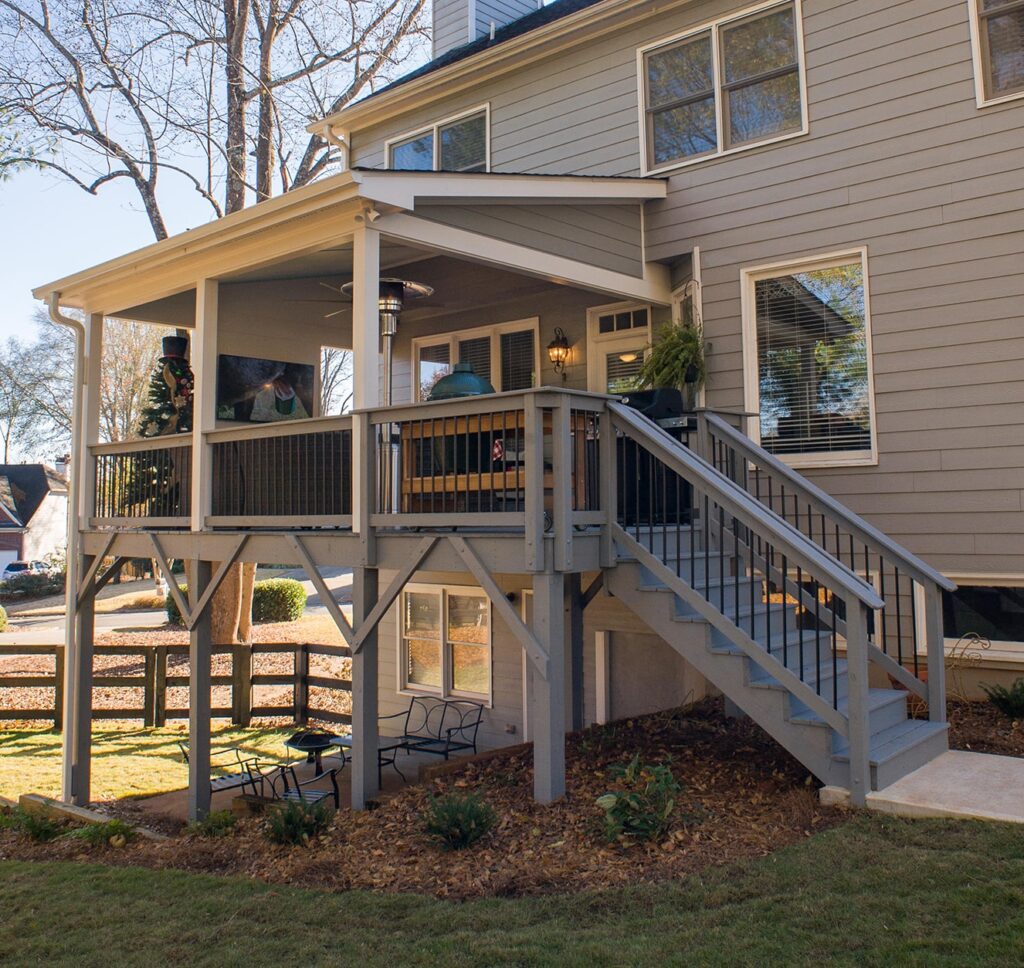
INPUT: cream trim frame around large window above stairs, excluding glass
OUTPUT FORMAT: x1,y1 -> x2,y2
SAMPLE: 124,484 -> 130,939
739,246 -> 879,468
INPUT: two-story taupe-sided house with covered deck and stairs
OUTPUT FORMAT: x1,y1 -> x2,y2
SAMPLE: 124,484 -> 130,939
36,0 -> 1024,812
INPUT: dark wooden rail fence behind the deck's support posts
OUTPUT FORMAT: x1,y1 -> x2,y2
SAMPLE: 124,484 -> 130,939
0,642 -> 352,729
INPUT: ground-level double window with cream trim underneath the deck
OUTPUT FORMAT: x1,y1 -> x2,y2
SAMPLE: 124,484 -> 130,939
398,585 -> 492,702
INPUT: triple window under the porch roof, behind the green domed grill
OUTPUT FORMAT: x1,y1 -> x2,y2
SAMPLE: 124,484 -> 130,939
413,319 -> 541,401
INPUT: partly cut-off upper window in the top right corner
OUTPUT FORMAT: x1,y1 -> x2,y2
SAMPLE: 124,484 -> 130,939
971,0 -> 1024,103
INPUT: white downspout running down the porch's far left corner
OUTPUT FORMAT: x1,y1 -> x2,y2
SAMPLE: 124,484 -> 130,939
47,292 -> 86,803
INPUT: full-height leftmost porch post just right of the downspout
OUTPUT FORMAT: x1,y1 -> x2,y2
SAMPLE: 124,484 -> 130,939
61,312 -> 103,805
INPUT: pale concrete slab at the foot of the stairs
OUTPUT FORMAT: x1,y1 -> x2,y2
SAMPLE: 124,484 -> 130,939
821,750 -> 1024,824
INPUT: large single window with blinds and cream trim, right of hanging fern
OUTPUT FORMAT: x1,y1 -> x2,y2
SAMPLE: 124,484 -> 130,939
743,250 -> 876,466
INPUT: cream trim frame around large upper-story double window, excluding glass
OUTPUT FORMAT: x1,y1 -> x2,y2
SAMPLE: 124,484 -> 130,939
637,0 -> 810,175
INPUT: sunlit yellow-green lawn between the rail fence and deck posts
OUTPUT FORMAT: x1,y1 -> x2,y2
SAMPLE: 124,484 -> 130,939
0,723 -> 295,800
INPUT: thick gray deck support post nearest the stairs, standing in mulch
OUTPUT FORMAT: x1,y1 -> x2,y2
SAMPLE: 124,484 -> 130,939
529,573 -> 565,803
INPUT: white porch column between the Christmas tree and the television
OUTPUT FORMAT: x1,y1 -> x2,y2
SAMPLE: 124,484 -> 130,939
189,279 -> 219,531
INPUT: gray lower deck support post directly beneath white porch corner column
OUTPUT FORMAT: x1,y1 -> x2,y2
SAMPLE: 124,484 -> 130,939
352,567 -> 379,810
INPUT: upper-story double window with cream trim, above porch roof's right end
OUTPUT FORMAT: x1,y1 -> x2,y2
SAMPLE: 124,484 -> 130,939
640,0 -> 807,172
